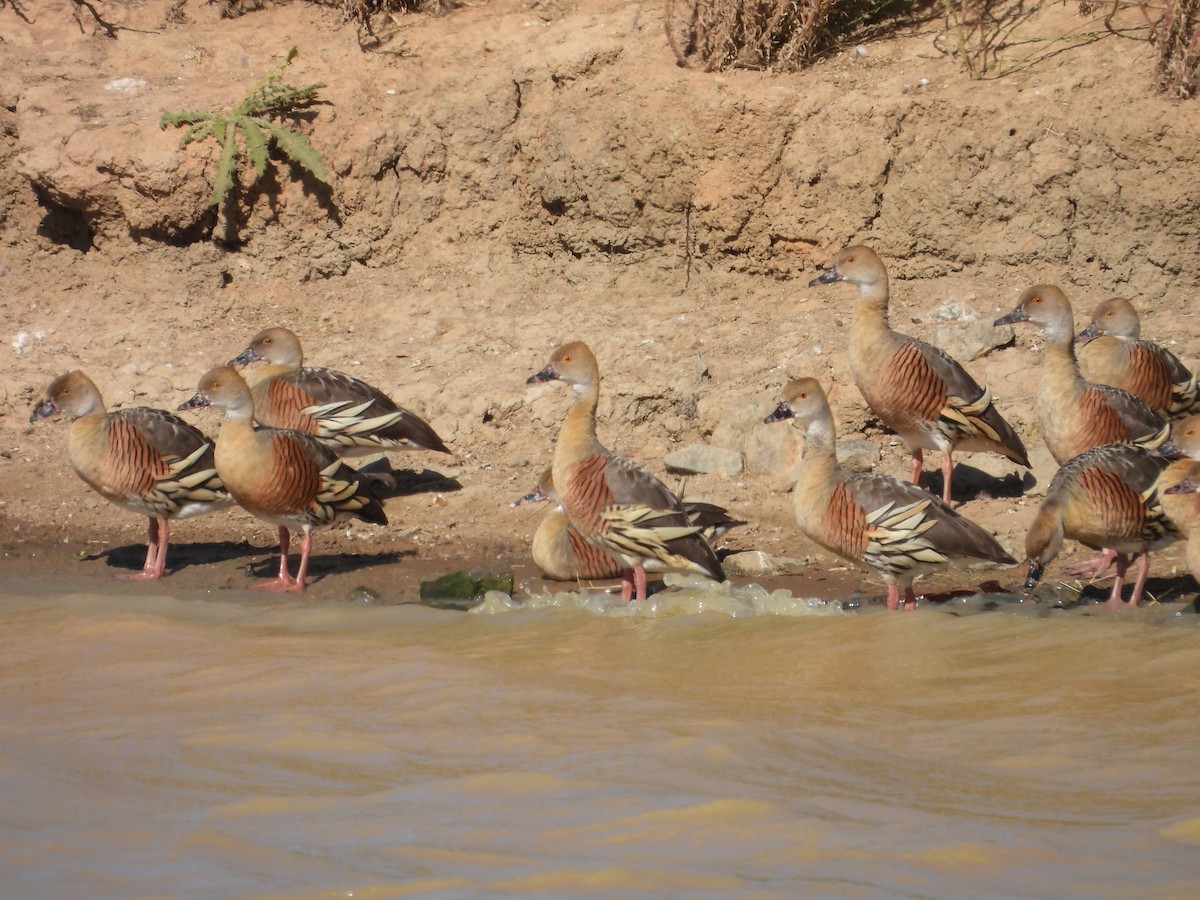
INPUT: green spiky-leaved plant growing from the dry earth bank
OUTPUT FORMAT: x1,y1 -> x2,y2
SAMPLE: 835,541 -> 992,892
158,47 -> 329,206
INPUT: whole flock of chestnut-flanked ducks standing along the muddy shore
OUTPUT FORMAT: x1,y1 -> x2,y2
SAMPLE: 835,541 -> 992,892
30,246 -> 1200,610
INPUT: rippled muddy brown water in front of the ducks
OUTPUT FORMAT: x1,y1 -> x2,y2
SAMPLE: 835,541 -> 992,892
0,564 -> 1200,898
